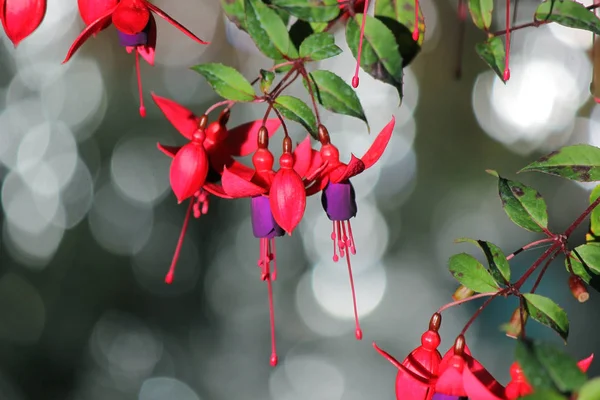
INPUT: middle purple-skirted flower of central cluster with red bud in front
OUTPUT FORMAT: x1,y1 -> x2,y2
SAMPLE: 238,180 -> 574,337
206,130 -> 321,366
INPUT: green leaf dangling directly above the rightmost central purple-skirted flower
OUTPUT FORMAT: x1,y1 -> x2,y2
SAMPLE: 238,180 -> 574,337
303,70 -> 369,128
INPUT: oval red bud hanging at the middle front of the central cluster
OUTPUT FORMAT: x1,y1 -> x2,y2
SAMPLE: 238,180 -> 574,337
269,168 -> 306,235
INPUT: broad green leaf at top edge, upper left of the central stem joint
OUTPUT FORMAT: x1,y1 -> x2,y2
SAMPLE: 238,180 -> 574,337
245,0 -> 295,60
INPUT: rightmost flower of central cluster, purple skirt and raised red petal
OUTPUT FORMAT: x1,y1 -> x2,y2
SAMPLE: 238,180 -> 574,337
308,117 -> 396,340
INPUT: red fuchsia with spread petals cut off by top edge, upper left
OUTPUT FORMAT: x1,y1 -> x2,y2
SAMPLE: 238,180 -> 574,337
63,0 -> 208,117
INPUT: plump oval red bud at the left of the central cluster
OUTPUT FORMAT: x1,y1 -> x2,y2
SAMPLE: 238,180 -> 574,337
169,143 -> 208,203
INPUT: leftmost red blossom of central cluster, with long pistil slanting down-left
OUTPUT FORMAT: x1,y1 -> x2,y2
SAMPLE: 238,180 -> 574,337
152,93 -> 281,283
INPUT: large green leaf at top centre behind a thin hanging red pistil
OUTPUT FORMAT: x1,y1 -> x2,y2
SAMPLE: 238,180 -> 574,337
346,14 -> 403,101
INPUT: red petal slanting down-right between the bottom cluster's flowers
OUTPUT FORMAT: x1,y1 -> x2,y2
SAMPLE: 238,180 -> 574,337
463,356 -> 506,400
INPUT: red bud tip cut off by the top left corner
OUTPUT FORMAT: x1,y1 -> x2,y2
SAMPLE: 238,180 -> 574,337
0,0 -> 46,47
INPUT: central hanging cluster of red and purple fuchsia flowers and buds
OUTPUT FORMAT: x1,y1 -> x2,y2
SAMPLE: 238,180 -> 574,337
152,94 -> 395,365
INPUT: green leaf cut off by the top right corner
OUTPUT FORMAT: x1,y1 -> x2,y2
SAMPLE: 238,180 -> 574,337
534,0 -> 600,35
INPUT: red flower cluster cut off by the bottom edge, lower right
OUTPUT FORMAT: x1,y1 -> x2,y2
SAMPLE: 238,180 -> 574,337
373,313 -> 594,400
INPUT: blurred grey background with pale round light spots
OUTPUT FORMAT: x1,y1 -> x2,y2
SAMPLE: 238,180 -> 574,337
0,0 -> 600,400
